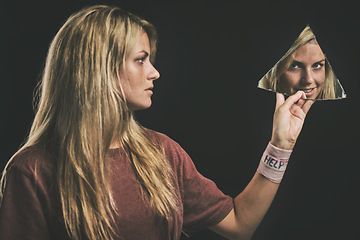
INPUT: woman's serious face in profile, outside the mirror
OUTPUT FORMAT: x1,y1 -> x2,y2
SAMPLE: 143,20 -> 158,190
120,31 -> 160,110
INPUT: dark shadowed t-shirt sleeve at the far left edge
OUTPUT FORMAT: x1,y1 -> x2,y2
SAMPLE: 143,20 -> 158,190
0,168 -> 51,240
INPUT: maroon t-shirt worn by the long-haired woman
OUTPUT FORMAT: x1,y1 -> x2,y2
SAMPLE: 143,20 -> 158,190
0,132 -> 233,240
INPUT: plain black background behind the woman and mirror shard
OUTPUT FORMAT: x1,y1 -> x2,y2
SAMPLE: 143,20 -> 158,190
0,0 -> 360,239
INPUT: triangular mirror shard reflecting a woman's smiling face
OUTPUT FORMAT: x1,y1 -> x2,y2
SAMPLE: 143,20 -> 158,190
258,26 -> 346,100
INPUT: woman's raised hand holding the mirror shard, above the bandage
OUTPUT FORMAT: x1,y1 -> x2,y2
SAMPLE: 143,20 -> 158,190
270,91 -> 314,150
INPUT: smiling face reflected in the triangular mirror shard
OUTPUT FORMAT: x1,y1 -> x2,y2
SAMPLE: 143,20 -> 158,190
279,40 -> 325,99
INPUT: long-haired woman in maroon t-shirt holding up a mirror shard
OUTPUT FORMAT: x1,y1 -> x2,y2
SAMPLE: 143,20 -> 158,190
0,6 -> 312,239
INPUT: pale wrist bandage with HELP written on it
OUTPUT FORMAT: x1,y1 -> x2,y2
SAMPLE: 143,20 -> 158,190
257,143 -> 292,183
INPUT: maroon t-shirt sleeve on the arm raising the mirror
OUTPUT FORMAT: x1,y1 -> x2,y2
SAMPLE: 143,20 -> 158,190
161,132 -> 234,236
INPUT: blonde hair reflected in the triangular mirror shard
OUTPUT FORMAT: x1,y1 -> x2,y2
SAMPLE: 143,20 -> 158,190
259,26 -> 342,99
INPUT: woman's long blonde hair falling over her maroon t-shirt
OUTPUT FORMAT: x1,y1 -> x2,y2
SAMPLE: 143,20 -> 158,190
0,5 -> 180,239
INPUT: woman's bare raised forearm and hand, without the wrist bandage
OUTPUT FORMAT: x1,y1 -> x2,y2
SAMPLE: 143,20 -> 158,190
210,92 -> 314,239
